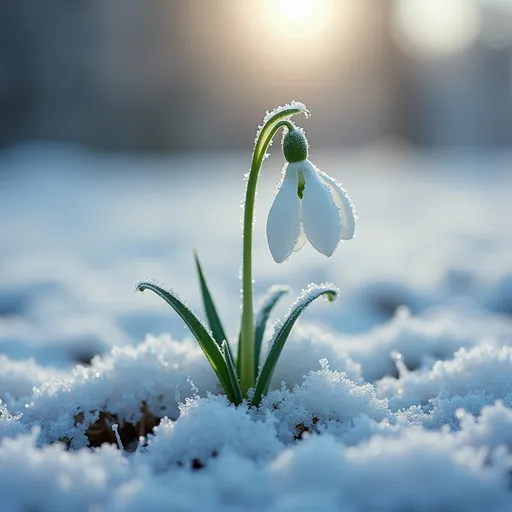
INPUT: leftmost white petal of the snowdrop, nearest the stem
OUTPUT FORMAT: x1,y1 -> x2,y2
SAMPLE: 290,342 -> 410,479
267,164 -> 300,263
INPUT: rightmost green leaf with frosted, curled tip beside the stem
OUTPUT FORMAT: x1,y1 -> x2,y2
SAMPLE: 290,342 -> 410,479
252,285 -> 338,406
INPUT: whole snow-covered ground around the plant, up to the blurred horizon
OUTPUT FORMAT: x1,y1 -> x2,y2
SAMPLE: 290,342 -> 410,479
0,145 -> 512,512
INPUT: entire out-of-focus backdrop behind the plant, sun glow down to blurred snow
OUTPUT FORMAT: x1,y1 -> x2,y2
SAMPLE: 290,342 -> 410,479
0,0 -> 512,368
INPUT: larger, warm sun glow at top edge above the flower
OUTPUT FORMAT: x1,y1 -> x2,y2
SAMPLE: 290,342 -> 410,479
236,0 -> 366,76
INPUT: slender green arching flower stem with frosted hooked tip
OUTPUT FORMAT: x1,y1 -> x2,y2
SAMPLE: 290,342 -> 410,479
239,107 -> 308,396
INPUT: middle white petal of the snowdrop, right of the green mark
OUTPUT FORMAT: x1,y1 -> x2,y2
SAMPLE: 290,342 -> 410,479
301,160 -> 341,256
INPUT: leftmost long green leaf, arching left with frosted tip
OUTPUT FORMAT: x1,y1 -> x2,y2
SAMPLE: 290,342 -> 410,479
137,281 -> 235,402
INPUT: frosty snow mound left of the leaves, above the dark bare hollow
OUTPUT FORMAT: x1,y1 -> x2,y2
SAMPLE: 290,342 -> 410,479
9,336 -> 220,448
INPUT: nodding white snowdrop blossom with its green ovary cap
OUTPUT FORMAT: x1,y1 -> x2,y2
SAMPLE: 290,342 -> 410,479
267,127 -> 355,263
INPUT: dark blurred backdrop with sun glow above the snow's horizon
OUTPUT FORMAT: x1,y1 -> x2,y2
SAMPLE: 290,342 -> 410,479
0,0 -> 512,152
